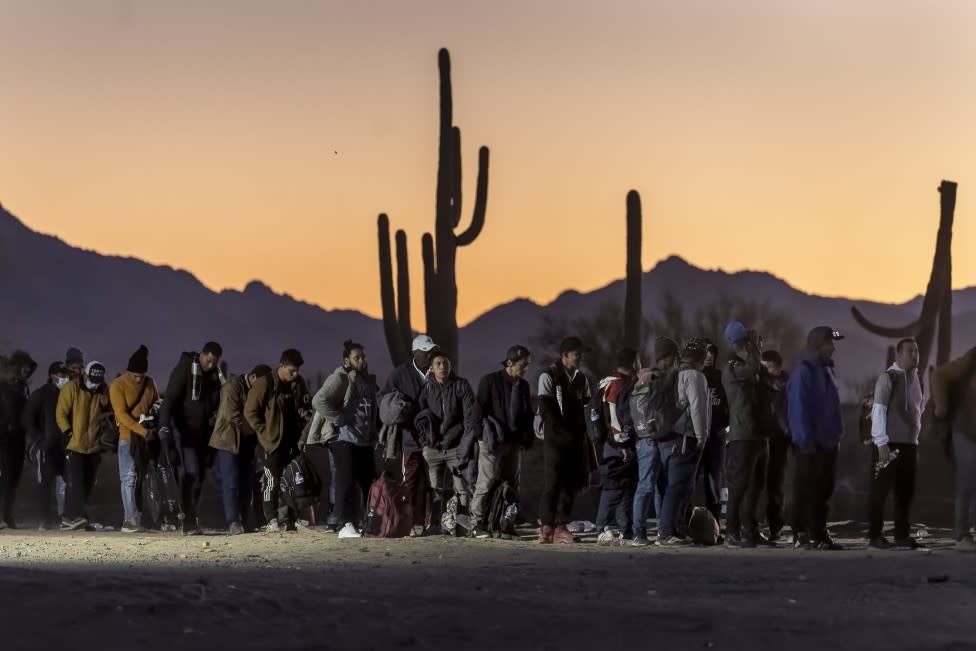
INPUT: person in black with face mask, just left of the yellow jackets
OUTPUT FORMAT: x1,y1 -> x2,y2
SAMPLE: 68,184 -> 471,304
24,362 -> 69,529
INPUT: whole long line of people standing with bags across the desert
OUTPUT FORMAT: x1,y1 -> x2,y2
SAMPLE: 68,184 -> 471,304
0,321 -> 976,551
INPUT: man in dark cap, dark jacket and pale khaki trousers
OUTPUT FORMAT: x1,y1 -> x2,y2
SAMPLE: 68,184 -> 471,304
461,346 -> 534,538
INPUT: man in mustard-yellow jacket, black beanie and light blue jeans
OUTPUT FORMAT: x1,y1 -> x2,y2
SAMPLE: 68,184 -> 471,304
108,346 -> 159,533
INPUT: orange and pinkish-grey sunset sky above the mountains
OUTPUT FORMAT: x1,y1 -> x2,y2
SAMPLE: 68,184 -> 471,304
0,0 -> 976,325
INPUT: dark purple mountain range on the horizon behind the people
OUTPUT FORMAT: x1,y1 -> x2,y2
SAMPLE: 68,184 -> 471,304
0,206 -> 976,398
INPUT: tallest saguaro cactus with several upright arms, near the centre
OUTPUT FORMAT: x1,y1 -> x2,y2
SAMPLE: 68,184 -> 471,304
380,49 -> 488,363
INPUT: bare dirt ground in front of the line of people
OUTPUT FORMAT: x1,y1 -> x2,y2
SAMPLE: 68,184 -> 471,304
0,524 -> 976,651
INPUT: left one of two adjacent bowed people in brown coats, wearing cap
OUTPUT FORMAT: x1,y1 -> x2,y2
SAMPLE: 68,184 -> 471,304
210,364 -> 272,536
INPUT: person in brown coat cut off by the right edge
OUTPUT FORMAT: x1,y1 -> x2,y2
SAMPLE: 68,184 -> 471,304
932,348 -> 976,552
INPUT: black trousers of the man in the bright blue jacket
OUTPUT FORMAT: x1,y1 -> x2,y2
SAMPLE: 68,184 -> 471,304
793,448 -> 837,542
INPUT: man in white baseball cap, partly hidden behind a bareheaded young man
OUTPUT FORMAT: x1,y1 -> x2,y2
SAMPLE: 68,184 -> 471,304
379,335 -> 437,536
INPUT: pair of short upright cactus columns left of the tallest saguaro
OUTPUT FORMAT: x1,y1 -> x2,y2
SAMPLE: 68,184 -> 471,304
377,213 -> 413,365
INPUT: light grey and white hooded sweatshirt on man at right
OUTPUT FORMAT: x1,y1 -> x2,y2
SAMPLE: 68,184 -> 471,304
871,362 -> 922,447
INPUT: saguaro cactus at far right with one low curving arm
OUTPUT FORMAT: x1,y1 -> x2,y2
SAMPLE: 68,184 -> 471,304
851,181 -> 957,369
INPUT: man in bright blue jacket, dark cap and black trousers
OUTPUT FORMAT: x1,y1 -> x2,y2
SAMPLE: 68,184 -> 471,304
787,326 -> 844,550
